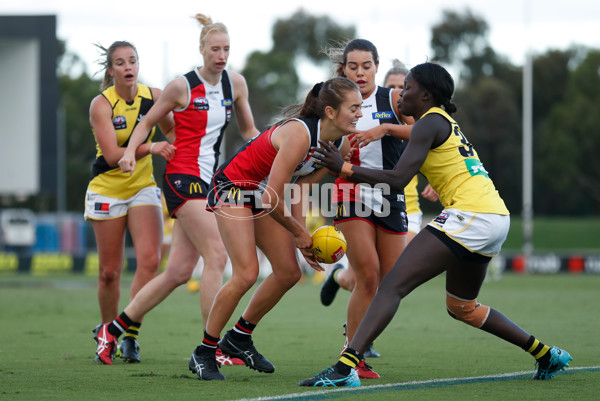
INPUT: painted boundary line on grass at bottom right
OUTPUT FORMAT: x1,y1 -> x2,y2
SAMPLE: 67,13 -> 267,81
237,366 -> 600,401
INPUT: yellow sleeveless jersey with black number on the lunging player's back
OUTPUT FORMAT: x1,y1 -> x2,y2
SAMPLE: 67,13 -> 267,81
420,107 -> 509,215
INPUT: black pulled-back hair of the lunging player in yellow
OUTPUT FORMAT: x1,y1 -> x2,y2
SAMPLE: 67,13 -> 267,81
410,62 -> 457,114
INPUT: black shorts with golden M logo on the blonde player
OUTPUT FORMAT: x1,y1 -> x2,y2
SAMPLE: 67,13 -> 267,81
163,174 -> 208,218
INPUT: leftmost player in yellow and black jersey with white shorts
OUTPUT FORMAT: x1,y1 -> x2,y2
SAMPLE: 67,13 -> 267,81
85,41 -> 175,362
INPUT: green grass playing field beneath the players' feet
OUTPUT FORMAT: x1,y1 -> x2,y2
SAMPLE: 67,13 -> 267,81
0,274 -> 600,401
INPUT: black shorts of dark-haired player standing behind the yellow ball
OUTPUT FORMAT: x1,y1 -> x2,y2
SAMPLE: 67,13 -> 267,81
333,201 -> 408,234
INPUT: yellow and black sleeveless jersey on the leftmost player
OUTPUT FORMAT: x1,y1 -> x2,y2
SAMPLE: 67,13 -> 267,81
88,84 -> 156,199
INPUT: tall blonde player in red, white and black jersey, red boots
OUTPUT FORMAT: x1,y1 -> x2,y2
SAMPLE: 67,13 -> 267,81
97,13 -> 259,364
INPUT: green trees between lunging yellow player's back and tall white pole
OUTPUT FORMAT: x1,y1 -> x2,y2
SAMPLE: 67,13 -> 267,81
431,9 -> 522,212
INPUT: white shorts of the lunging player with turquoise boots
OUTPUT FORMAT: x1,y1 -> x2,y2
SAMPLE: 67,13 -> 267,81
428,209 -> 510,257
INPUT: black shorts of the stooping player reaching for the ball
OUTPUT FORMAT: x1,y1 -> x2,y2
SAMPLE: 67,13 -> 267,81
206,170 -> 266,215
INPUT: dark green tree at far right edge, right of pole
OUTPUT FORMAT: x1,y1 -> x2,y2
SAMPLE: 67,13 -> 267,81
538,50 -> 600,215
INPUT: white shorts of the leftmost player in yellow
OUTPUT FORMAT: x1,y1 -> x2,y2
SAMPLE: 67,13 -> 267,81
83,186 -> 162,220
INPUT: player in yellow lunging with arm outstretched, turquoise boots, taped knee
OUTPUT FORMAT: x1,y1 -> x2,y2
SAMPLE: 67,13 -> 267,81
299,63 -> 572,387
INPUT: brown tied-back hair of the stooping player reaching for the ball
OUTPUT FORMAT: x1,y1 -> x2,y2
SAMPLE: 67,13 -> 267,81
278,77 -> 359,123
